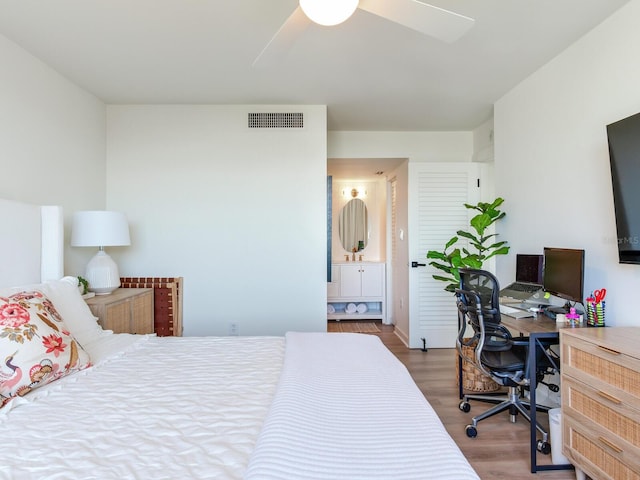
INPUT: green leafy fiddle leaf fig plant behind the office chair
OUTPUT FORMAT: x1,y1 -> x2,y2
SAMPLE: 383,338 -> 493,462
427,197 -> 509,292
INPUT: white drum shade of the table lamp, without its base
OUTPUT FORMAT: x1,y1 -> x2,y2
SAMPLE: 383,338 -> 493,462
71,210 -> 131,247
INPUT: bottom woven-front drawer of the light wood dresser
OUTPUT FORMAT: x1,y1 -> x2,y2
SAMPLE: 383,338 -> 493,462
562,412 -> 640,480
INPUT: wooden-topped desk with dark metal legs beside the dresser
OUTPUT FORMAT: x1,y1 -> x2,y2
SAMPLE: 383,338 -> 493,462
500,314 -> 587,473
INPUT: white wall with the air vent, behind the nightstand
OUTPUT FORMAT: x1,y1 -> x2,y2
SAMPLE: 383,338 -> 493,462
107,105 -> 327,335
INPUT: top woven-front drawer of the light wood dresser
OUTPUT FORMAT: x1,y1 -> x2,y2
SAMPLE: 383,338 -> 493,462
562,335 -> 640,405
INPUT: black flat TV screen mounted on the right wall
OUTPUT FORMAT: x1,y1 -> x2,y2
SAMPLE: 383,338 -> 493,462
607,113 -> 640,264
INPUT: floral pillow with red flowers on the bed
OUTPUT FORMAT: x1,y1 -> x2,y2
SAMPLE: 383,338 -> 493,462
0,291 -> 91,408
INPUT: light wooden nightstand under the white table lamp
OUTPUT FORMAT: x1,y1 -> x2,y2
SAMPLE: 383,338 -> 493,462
86,288 -> 153,334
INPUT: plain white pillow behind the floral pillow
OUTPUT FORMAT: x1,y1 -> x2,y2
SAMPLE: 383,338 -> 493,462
0,277 -> 112,345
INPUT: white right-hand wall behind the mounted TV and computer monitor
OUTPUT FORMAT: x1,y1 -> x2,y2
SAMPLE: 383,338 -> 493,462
495,0 -> 640,325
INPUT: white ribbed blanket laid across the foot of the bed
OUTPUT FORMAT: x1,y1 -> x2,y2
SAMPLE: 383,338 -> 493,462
245,333 -> 479,480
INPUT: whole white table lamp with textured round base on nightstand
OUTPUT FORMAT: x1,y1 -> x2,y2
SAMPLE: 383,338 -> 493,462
71,210 -> 131,295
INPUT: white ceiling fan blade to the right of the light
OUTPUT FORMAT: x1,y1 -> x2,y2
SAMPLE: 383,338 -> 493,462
358,0 -> 475,43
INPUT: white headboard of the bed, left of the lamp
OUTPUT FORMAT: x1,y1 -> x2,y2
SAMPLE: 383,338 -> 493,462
0,199 -> 64,287
